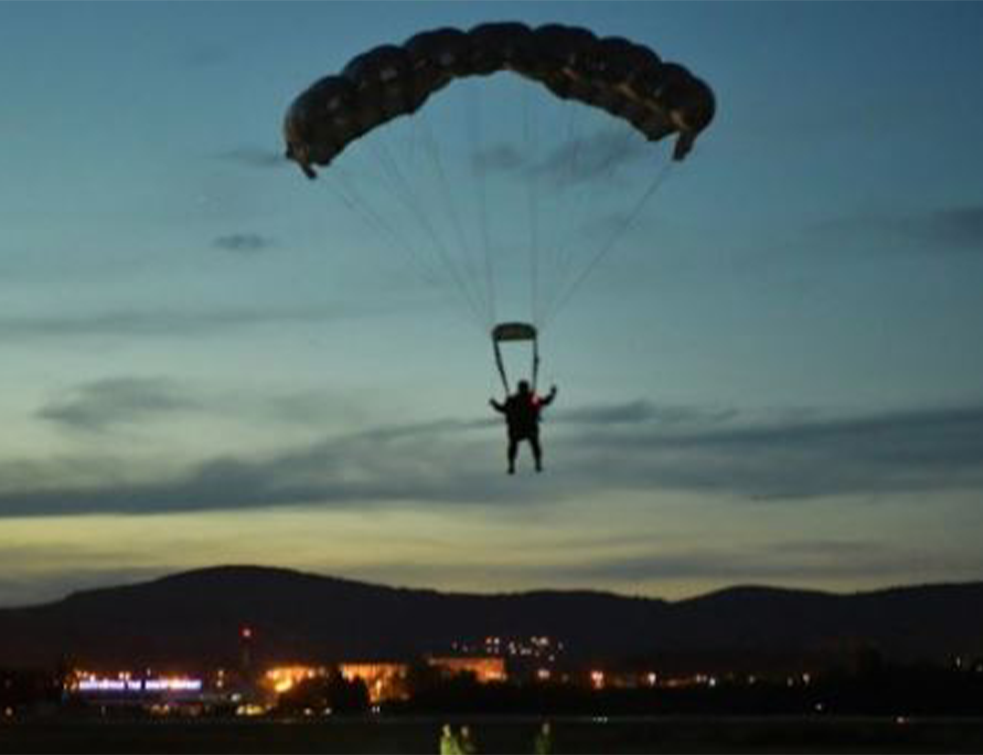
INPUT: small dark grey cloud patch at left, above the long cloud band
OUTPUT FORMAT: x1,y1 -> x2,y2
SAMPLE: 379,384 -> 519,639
37,378 -> 198,432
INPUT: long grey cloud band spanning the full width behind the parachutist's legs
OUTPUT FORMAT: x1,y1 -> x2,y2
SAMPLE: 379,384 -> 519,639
0,402 -> 983,516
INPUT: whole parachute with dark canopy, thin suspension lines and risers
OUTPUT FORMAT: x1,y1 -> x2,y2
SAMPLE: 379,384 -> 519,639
283,22 -> 716,389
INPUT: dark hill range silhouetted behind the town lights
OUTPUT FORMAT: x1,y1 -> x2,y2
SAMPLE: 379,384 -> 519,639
0,566 -> 983,667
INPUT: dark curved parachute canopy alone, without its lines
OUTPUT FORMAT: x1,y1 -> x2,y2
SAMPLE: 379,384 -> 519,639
284,22 -> 715,178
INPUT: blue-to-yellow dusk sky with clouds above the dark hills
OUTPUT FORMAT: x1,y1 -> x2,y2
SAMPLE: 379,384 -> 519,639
0,1 -> 983,605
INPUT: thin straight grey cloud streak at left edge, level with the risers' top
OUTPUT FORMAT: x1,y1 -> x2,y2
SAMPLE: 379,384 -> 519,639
0,307 -> 343,341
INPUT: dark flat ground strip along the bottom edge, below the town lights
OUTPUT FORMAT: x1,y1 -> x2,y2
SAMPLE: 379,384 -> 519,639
0,716 -> 983,753
